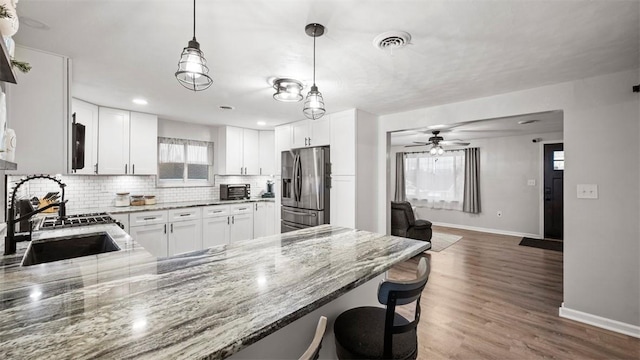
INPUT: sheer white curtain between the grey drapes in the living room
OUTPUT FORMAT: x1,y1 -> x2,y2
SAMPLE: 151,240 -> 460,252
404,151 -> 464,210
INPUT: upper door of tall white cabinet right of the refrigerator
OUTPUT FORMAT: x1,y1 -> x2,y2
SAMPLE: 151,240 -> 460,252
331,110 -> 356,175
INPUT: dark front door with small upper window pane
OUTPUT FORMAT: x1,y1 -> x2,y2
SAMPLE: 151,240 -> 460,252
544,144 -> 564,240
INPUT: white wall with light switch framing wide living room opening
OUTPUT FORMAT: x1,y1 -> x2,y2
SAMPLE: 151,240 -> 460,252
378,69 -> 640,336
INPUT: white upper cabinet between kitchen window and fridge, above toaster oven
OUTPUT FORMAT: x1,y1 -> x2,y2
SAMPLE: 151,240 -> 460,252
217,126 -> 274,175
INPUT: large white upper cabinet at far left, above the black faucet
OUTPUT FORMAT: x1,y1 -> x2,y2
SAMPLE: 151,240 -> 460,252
2,46 -> 71,174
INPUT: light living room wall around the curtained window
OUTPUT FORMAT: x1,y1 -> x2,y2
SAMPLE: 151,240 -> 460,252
389,133 -> 562,237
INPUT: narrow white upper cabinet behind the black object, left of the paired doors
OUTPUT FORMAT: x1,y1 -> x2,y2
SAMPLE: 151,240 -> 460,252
69,99 -> 98,174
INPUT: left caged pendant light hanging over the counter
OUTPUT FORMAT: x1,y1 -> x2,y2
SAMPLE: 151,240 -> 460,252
176,0 -> 213,91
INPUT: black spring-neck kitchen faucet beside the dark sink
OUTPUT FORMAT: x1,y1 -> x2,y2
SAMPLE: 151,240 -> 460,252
4,175 -> 68,255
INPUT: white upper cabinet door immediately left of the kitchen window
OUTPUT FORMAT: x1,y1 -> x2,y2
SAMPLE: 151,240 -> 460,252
129,112 -> 158,175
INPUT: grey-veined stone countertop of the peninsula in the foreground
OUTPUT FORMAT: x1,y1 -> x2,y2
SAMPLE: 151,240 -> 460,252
0,225 -> 426,359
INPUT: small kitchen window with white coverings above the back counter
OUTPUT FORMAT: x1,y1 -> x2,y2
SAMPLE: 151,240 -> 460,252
158,137 -> 213,185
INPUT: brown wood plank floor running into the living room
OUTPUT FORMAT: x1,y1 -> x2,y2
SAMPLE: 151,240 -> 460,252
390,227 -> 640,360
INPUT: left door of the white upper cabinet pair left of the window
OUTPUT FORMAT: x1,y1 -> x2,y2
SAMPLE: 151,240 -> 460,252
98,107 -> 131,175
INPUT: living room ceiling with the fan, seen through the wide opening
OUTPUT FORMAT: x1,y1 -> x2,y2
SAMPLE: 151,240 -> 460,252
391,111 -> 564,148
